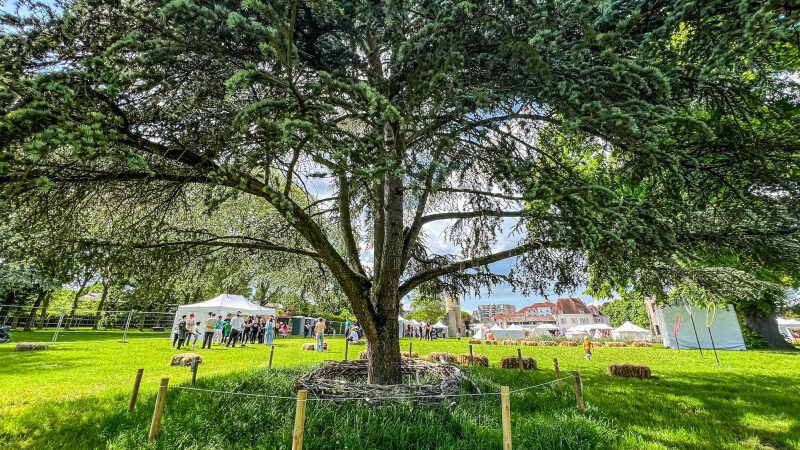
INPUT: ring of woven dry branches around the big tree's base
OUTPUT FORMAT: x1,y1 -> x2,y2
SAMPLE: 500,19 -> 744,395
300,358 -> 480,404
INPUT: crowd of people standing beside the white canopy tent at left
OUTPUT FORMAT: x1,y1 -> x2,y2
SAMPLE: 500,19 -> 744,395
172,311 -> 289,349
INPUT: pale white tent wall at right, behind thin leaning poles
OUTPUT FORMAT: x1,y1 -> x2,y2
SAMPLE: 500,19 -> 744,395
654,303 -> 747,350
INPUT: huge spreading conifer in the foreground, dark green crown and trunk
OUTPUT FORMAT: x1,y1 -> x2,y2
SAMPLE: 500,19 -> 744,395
0,0 -> 800,383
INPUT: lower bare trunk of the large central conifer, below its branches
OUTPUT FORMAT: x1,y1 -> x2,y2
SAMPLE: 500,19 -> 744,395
365,316 -> 403,385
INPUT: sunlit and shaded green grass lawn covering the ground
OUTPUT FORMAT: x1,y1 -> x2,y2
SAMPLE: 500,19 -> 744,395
0,332 -> 800,449
